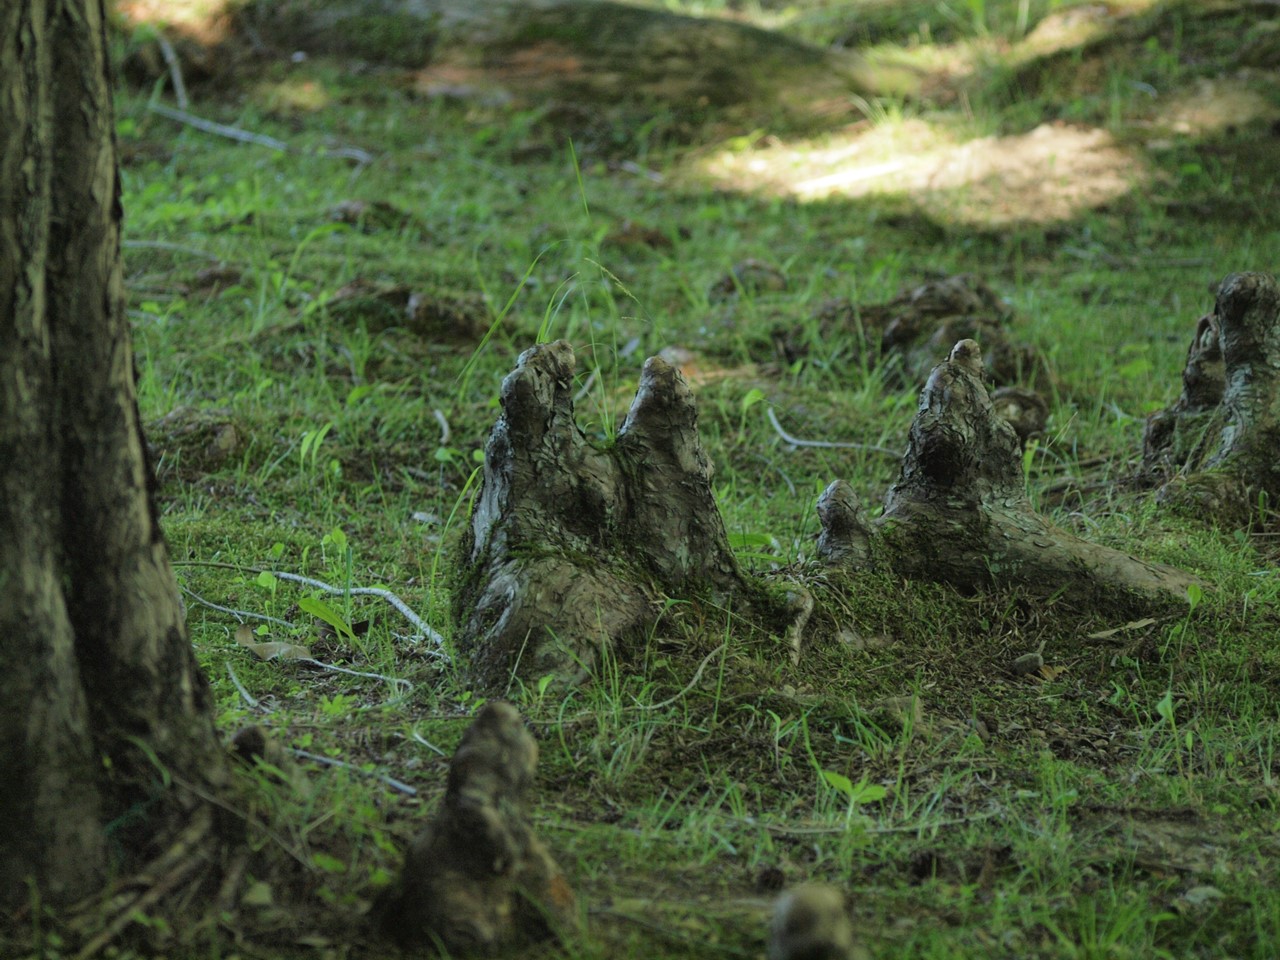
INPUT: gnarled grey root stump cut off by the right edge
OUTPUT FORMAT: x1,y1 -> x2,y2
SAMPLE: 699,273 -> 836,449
1140,273 -> 1280,526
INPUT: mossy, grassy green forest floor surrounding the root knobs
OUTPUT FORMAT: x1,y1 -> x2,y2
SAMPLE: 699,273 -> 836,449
97,0 -> 1280,960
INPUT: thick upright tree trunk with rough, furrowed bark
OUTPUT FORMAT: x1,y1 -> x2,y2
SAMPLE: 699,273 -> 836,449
0,0 -> 225,915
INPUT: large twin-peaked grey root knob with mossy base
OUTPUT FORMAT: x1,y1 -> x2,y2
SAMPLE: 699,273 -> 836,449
454,342 -> 742,691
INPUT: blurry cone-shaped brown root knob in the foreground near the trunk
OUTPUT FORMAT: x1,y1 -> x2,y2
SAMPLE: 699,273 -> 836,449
374,700 -> 576,955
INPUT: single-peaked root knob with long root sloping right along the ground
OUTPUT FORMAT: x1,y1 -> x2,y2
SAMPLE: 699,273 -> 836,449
818,340 -> 1197,605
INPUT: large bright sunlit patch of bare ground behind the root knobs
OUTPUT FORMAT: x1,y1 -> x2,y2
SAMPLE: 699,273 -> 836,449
701,120 -> 1147,225
